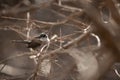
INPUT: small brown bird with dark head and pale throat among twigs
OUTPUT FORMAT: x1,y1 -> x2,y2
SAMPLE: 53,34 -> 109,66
14,33 -> 50,50
